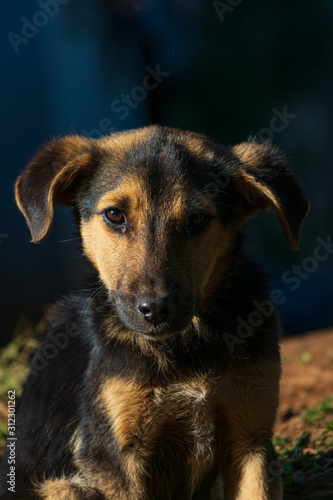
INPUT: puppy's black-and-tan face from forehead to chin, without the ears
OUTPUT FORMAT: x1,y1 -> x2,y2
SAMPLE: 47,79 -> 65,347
79,132 -> 235,338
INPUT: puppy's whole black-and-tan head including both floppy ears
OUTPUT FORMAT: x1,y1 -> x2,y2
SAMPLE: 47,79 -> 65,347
16,126 -> 309,339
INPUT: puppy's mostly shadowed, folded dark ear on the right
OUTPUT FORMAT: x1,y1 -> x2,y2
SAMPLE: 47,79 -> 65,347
230,142 -> 310,250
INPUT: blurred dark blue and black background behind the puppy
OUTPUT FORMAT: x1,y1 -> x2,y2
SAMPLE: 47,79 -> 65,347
0,0 -> 333,342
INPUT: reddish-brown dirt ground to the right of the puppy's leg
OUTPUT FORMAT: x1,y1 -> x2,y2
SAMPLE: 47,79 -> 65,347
275,329 -> 333,500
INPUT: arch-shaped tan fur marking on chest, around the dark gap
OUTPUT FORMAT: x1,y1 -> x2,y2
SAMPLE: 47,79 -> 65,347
96,376 -> 215,495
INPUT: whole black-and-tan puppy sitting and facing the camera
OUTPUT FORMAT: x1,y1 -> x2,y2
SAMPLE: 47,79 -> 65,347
1,126 -> 309,500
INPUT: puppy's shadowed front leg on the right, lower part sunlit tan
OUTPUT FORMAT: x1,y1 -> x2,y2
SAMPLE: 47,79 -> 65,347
220,360 -> 283,500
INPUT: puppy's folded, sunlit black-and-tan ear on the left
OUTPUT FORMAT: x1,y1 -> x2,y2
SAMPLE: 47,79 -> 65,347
15,135 -> 93,243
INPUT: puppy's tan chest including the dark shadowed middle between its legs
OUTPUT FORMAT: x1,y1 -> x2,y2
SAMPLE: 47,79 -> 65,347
102,378 -> 215,498
